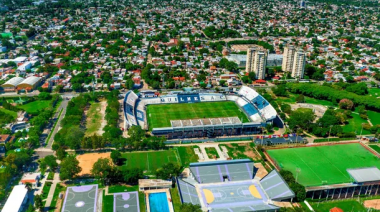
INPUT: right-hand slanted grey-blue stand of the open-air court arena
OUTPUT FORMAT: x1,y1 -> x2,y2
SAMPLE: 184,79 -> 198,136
260,169 -> 294,201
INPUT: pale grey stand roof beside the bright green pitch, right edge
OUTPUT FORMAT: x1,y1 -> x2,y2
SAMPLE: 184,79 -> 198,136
347,167 -> 380,183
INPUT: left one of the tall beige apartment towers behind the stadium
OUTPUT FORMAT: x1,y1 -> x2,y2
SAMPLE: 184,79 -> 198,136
246,46 -> 268,79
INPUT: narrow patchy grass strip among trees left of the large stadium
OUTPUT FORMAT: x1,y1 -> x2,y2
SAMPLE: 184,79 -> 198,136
85,102 -> 102,136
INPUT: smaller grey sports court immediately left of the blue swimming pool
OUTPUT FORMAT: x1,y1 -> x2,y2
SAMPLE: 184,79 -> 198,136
113,191 -> 140,212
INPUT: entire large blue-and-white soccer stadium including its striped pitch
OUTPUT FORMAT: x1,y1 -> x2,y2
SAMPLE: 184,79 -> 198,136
124,86 -> 283,139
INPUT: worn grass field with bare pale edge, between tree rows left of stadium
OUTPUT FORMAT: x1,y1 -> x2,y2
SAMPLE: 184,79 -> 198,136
86,101 -> 107,136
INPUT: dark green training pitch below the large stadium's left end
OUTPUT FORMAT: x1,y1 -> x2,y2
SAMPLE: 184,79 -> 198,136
121,150 -> 180,173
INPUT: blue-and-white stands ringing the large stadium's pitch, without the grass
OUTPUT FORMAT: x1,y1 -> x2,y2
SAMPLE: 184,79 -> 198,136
124,86 -> 283,139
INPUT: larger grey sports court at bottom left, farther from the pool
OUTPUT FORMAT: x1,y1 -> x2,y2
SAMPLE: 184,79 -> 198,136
62,185 -> 98,212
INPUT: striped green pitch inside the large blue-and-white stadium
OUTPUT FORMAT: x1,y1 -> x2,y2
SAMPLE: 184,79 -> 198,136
147,101 -> 249,130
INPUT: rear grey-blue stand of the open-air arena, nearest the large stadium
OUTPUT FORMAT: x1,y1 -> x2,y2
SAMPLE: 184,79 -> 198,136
190,159 -> 254,183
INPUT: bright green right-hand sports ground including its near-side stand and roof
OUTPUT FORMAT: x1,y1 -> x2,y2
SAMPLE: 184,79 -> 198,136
265,143 -> 380,199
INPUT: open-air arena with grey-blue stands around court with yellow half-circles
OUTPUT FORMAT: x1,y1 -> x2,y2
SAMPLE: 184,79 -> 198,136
177,159 -> 295,212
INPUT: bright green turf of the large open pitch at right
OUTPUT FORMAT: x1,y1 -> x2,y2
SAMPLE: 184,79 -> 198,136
268,143 -> 380,186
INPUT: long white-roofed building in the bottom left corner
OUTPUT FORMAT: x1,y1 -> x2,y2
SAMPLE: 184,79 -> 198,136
1,185 -> 28,212
